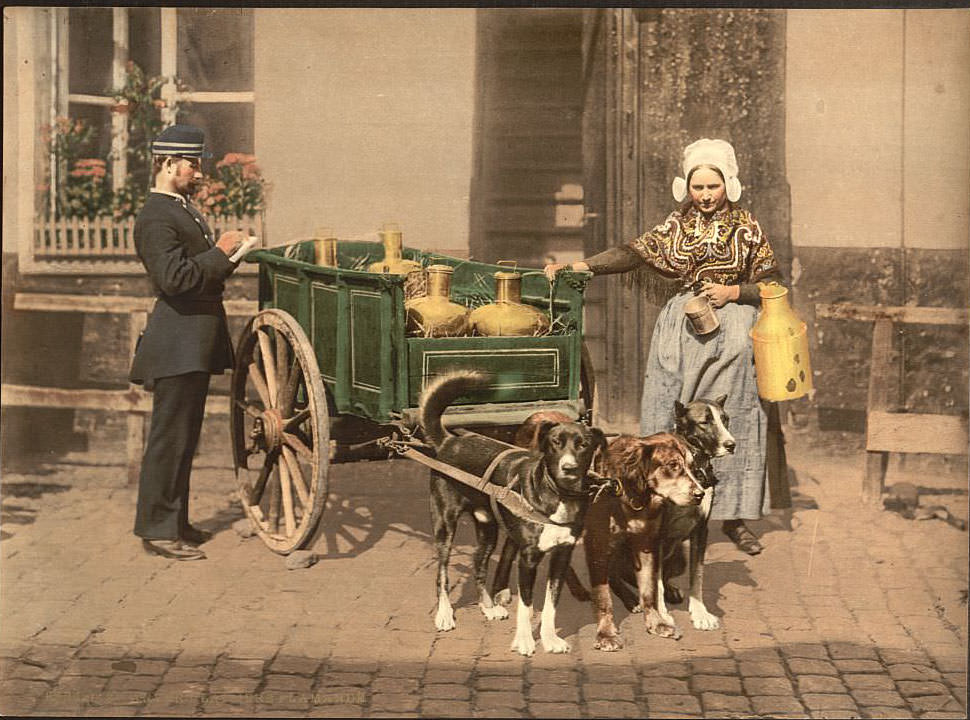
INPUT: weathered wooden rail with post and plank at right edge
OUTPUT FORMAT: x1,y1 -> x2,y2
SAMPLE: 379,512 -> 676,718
815,303 -> 970,503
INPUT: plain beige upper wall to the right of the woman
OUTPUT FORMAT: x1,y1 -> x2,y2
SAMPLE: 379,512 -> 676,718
786,10 -> 970,250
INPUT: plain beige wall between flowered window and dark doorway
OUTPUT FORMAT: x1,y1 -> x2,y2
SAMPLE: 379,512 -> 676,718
255,9 -> 475,251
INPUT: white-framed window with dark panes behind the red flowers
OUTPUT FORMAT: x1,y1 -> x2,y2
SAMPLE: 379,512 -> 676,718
49,7 -> 254,208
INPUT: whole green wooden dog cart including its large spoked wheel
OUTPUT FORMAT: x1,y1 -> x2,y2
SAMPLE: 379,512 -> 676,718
230,241 -> 593,554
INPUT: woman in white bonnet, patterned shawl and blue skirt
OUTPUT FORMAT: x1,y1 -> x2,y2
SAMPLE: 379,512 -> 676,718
545,138 -> 781,555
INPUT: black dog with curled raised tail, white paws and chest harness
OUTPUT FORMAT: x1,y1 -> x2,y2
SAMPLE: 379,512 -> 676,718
420,372 -> 605,656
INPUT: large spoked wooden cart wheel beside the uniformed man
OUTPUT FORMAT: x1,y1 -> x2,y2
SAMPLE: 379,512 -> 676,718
229,309 -> 330,555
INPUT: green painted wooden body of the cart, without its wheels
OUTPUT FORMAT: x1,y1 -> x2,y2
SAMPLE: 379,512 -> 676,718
247,241 -> 586,422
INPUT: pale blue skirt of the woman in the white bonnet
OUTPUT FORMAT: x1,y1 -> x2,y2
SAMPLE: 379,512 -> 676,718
640,292 -> 770,520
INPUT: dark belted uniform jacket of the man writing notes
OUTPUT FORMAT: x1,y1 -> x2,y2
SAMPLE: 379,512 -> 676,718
129,192 -> 235,390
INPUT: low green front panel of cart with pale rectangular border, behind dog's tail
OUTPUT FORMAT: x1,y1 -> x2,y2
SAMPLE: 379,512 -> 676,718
407,335 -> 576,407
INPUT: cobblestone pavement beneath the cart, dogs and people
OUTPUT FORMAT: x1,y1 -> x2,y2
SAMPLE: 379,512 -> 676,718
0,430 -> 968,718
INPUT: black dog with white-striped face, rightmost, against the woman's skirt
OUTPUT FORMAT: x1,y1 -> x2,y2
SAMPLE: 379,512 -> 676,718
580,395 -> 735,630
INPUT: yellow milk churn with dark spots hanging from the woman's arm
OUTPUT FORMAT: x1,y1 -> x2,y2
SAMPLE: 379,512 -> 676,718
751,283 -> 812,401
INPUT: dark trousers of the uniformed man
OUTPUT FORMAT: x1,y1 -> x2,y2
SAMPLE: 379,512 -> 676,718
135,372 -> 209,540
